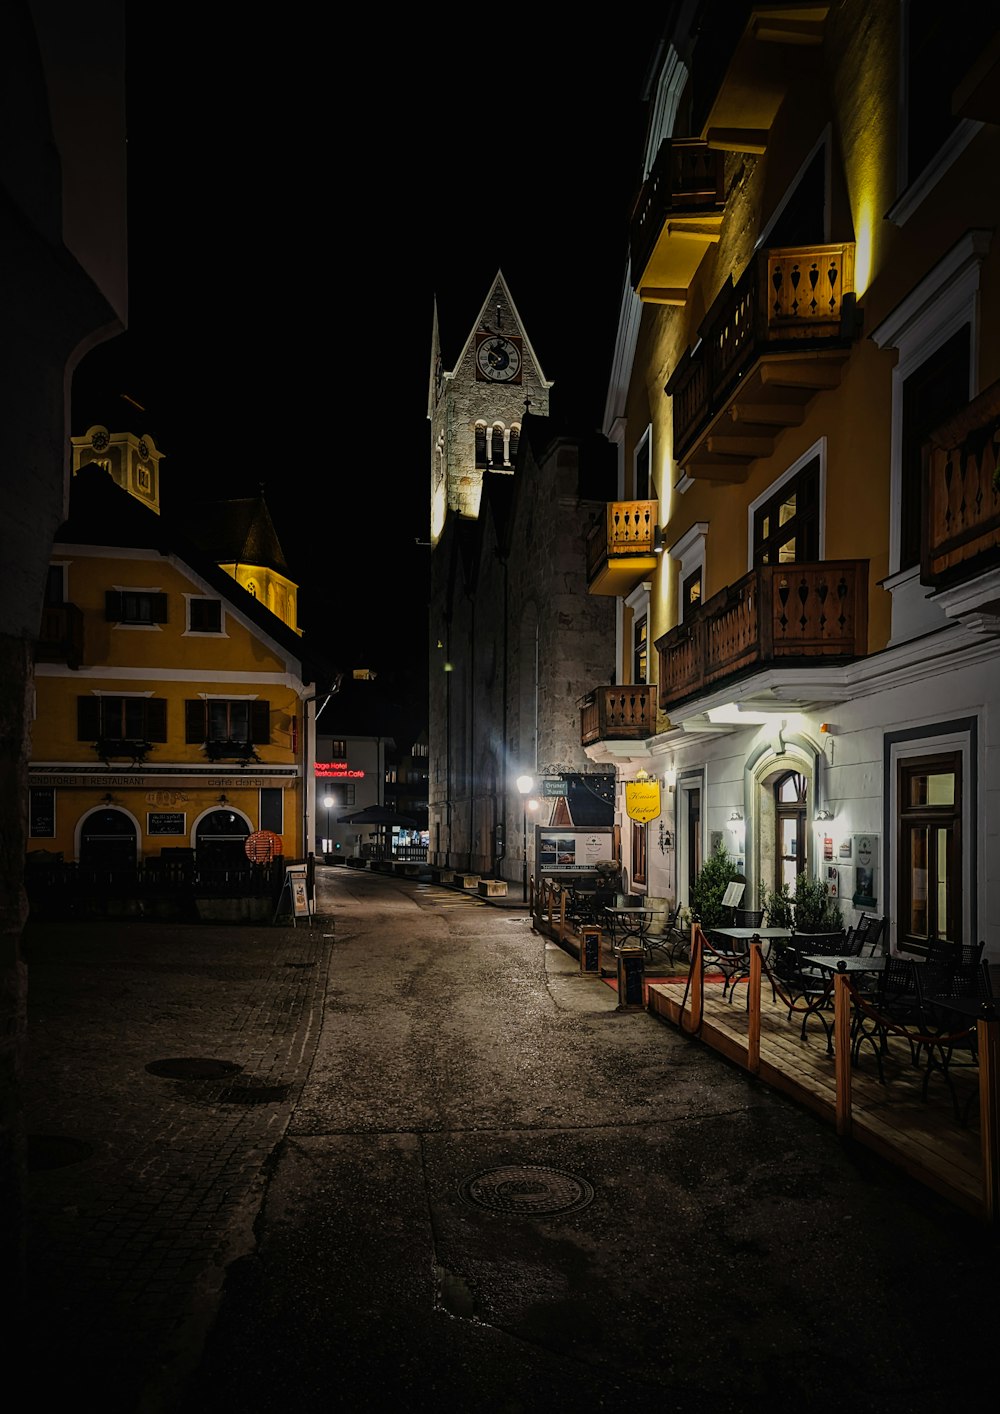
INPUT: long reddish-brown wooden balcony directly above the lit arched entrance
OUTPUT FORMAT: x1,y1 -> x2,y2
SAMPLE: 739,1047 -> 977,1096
656,560 -> 868,711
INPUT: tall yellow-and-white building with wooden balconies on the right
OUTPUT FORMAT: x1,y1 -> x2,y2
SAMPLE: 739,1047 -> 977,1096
581,0 -> 1000,960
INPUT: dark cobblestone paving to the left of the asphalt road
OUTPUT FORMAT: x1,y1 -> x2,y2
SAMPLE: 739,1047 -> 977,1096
23,918 -> 332,1411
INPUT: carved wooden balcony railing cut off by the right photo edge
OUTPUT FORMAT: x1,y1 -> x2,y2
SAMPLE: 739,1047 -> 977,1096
921,380 -> 1000,587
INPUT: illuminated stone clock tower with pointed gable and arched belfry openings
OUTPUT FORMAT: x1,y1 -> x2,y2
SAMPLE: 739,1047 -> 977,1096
427,271 -> 552,544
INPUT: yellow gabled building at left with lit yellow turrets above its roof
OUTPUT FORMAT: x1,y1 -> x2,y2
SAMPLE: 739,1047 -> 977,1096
28,427 -> 331,882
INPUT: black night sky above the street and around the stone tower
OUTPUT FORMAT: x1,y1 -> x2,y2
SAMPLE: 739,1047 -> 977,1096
72,15 -> 664,669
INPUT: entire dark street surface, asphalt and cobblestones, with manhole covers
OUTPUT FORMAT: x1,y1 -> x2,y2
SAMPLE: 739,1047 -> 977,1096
17,868 -> 999,1414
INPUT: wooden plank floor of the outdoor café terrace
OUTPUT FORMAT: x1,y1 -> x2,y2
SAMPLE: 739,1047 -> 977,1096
646,977 -> 984,1217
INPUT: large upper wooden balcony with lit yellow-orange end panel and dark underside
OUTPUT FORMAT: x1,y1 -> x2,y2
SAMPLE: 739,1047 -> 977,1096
665,243 -> 860,481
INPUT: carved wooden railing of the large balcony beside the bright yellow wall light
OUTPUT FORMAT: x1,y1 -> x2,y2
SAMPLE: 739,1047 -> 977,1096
665,243 -> 859,461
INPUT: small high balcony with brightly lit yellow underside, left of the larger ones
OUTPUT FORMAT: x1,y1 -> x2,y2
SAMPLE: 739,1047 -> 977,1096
629,139 -> 726,304
